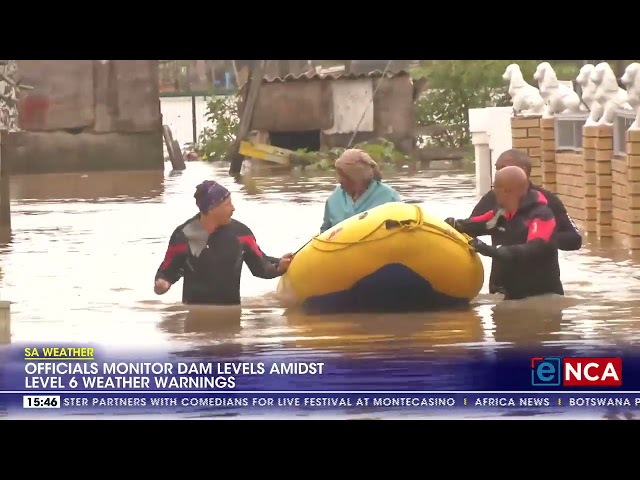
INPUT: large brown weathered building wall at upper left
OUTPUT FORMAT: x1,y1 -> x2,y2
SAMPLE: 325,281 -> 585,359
7,60 -> 164,173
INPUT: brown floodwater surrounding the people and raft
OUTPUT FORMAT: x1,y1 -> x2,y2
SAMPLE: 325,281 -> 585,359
0,163 -> 640,420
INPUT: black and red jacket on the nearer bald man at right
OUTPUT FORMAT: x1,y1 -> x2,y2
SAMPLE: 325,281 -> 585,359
461,189 -> 564,300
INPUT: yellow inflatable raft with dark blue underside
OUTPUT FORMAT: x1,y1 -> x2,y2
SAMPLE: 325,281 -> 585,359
278,202 -> 484,313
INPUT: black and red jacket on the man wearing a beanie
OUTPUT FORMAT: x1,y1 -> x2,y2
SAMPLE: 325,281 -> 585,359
155,214 -> 279,305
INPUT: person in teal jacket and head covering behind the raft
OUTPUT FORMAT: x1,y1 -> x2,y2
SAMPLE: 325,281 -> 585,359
320,148 -> 402,233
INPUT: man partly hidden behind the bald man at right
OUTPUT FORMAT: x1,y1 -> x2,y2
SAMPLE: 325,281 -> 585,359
464,149 -> 582,293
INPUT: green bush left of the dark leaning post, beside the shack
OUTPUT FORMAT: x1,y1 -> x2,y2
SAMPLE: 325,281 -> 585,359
194,95 -> 240,162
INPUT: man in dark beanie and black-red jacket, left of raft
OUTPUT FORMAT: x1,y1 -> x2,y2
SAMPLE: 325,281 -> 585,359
154,180 -> 293,305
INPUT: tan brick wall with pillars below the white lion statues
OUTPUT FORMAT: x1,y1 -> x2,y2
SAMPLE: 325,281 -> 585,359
511,117 -> 640,249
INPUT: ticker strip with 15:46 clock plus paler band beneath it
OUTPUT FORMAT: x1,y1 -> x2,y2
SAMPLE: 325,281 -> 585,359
0,391 -> 640,417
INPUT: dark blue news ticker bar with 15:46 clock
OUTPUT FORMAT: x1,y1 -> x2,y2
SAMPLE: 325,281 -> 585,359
0,391 -> 640,412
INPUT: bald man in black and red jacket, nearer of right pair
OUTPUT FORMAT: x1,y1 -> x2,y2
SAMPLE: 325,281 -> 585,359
447,166 -> 564,300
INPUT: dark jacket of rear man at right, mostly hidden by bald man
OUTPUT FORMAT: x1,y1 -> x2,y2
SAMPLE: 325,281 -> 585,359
471,184 -> 582,293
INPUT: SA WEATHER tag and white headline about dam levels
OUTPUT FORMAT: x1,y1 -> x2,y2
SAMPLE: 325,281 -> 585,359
24,347 -> 324,390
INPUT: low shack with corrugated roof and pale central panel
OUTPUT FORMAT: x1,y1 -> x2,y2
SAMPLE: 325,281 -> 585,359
241,71 -> 420,154
